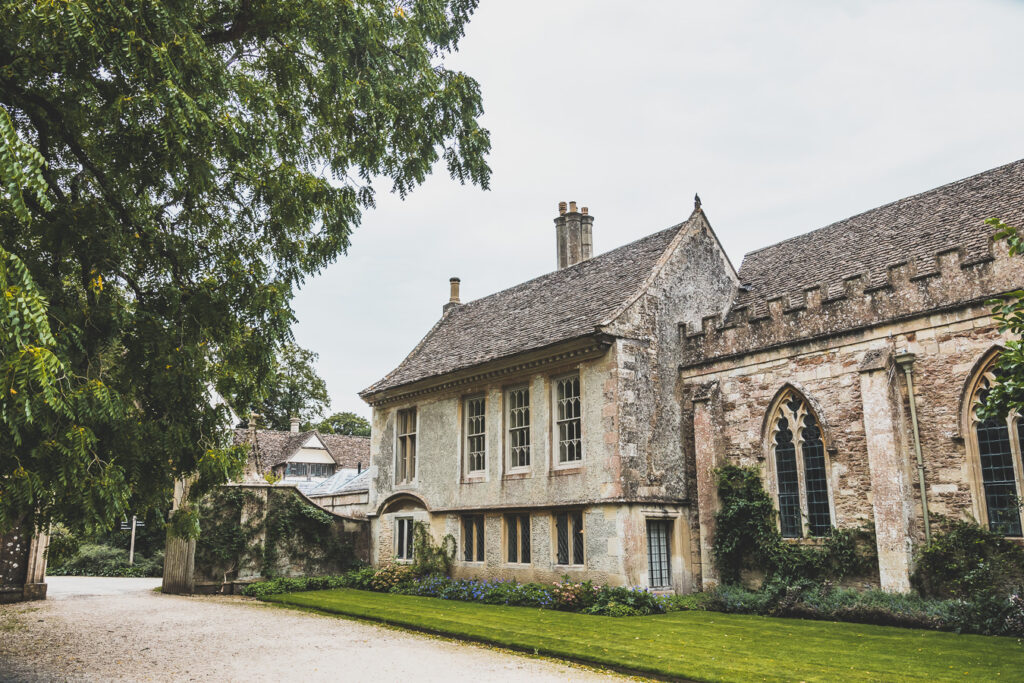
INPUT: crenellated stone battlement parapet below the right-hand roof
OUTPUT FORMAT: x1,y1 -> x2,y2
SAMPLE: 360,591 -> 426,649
679,242 -> 1024,367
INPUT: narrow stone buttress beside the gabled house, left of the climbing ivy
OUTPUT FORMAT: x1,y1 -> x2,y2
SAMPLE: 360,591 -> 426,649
693,382 -> 724,590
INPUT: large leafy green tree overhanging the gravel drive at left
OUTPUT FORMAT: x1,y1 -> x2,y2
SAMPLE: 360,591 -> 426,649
0,0 -> 489,529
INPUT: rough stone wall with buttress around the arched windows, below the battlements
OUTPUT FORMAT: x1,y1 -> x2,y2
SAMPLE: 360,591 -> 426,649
682,305 -> 1006,590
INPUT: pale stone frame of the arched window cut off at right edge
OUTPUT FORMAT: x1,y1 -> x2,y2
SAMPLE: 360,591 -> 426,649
963,347 -> 1024,539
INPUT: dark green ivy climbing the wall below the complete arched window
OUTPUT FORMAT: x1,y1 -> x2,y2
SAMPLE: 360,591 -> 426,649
713,465 -> 878,584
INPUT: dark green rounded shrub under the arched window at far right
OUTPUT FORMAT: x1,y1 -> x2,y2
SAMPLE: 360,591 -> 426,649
910,520 -> 1024,598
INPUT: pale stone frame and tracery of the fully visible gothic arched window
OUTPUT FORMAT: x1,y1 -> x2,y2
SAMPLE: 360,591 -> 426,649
765,385 -> 836,541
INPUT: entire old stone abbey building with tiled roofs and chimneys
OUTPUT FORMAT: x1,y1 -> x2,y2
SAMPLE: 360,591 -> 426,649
361,161 -> 1024,592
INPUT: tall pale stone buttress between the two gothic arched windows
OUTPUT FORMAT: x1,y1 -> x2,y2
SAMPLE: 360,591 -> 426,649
859,348 -> 912,593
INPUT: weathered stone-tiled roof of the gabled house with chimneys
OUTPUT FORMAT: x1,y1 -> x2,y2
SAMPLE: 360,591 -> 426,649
359,223 -> 684,396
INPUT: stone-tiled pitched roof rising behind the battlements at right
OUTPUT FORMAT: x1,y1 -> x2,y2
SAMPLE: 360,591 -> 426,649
733,160 -> 1024,317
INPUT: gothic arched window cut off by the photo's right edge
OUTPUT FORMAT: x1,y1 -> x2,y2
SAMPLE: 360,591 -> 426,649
967,351 -> 1024,536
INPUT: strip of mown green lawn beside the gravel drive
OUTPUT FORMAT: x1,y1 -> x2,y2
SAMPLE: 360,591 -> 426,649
266,589 -> 1024,681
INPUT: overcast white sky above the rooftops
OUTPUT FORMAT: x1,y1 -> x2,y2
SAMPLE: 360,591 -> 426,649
295,0 -> 1024,417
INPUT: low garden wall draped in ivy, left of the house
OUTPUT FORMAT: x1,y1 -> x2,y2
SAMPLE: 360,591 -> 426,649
195,484 -> 370,593
